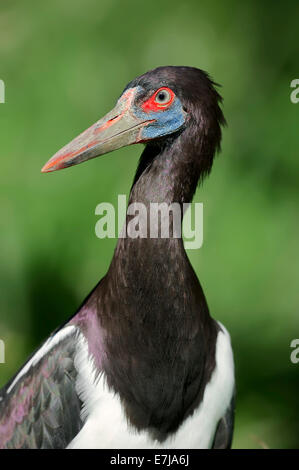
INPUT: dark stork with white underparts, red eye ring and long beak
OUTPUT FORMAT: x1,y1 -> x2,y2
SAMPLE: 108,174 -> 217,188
0,66 -> 235,449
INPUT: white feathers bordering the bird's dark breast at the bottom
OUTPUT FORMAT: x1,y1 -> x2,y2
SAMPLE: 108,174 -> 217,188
68,325 -> 234,449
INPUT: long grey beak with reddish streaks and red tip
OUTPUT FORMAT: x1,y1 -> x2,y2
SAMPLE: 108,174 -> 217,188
42,88 -> 152,173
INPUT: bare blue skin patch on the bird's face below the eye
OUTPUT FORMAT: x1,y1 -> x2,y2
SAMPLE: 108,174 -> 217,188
133,87 -> 186,140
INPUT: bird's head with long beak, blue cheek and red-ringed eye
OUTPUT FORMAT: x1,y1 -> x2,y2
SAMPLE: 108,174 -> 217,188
42,66 -> 224,172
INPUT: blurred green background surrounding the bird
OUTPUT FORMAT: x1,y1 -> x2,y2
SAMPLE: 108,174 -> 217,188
0,0 -> 299,448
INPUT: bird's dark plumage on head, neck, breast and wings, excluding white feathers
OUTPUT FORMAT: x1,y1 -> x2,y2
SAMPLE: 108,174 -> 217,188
0,67 -> 233,448
